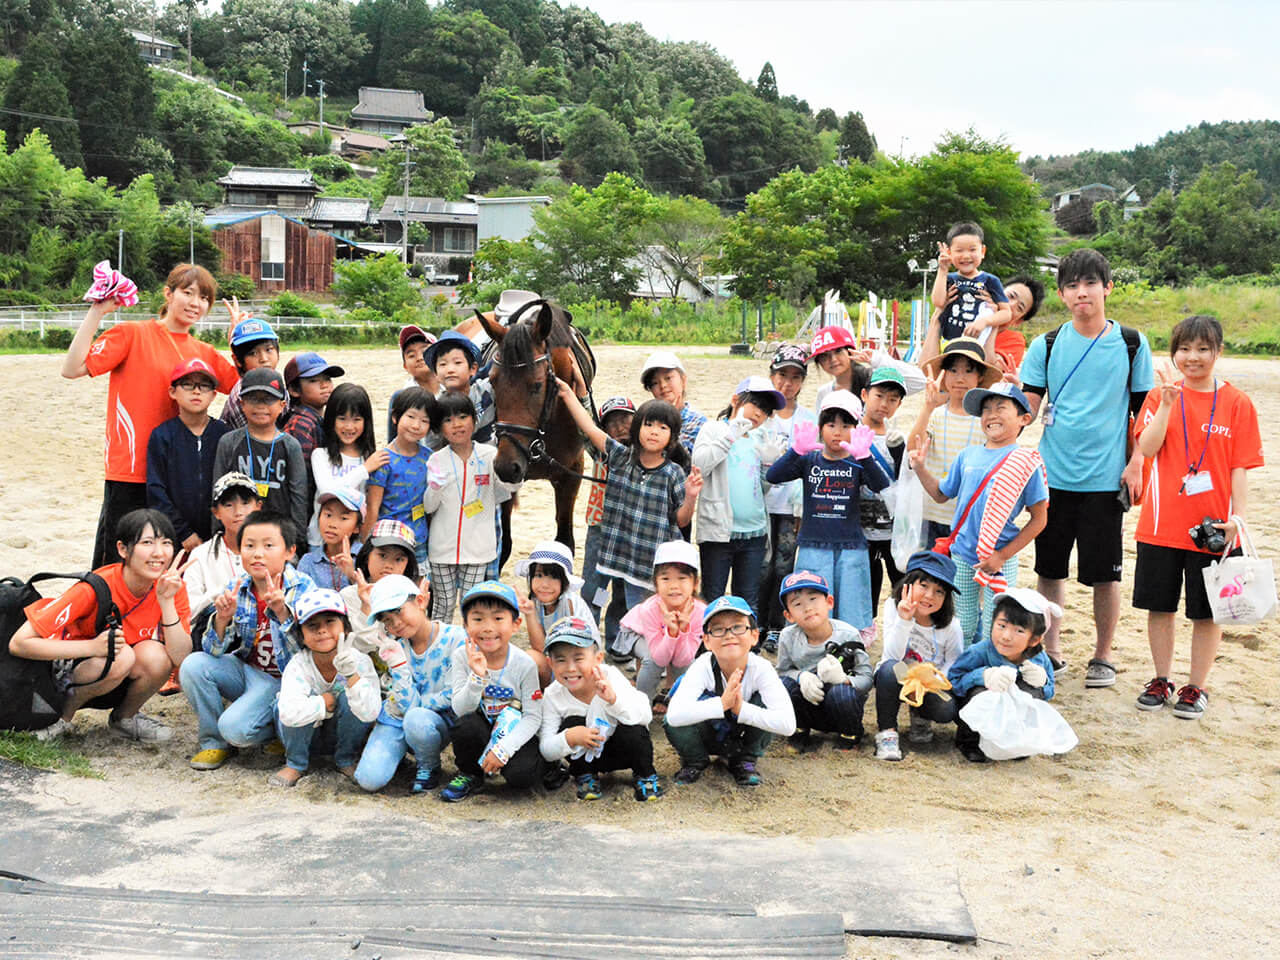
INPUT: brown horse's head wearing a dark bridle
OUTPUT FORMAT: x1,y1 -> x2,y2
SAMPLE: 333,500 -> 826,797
476,301 -> 556,484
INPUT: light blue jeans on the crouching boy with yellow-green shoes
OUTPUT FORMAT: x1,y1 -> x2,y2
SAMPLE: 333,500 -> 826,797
178,652 -> 280,750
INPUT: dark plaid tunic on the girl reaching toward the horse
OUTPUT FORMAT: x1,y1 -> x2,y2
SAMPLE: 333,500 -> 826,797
598,436 -> 685,589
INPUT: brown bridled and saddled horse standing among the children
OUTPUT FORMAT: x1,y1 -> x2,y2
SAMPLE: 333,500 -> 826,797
476,300 -> 595,568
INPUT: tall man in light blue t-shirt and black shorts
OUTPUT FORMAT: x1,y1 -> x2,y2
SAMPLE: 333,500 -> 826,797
1020,250 -> 1155,687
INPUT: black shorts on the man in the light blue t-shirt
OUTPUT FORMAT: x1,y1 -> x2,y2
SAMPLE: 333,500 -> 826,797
1036,488 -> 1124,586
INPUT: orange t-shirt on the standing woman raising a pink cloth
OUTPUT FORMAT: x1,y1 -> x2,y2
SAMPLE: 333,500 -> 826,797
84,320 -> 239,484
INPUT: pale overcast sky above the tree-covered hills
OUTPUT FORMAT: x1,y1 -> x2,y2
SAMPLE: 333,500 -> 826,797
578,0 -> 1280,157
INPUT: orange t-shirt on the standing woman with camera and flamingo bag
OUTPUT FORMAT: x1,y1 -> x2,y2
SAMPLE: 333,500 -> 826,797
1134,380 -> 1262,553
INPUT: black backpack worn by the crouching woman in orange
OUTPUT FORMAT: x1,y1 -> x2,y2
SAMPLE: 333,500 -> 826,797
0,573 -> 120,730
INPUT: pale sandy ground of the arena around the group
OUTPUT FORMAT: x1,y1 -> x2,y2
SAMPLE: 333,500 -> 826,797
0,347 -> 1280,957
